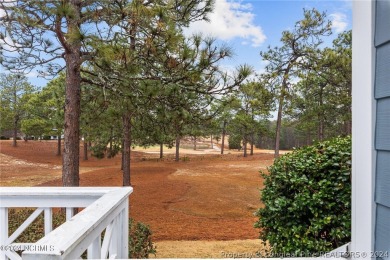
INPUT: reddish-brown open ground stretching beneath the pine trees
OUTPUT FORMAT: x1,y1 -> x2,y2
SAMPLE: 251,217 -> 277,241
0,141 -> 272,241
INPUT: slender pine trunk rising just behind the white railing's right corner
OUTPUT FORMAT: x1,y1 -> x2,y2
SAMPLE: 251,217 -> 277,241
123,112 -> 131,186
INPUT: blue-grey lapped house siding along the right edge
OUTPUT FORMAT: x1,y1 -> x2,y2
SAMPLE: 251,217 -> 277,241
374,0 -> 390,259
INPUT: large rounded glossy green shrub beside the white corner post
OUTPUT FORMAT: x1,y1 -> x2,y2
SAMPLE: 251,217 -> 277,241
255,137 -> 351,255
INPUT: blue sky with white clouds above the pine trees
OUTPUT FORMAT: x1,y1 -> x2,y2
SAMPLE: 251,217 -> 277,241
0,0 -> 352,86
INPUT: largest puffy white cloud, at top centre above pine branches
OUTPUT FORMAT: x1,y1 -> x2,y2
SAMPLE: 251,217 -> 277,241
185,0 -> 266,47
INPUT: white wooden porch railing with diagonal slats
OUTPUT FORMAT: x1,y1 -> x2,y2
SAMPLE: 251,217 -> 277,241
0,187 -> 133,260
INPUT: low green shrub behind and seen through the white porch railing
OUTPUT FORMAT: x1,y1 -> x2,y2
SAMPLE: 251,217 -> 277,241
8,209 -> 156,258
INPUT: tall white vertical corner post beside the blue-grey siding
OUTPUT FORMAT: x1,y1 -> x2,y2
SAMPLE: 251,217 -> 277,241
351,0 -> 376,254
